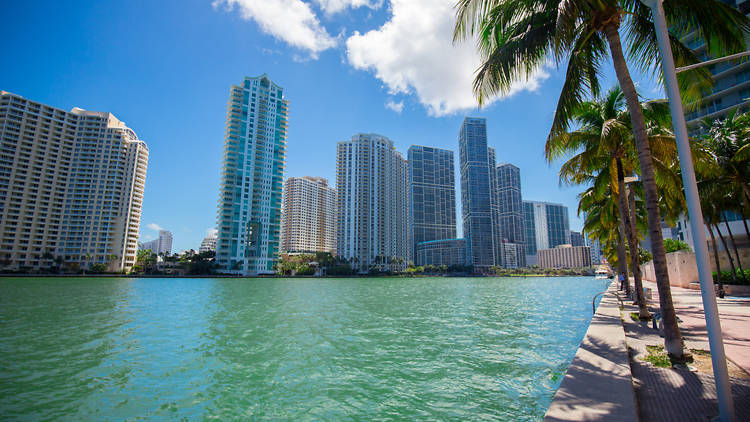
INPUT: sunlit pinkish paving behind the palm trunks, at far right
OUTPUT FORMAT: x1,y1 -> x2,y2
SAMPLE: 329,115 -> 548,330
643,281 -> 750,373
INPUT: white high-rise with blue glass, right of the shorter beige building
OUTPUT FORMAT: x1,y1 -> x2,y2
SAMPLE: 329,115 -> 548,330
336,133 -> 409,272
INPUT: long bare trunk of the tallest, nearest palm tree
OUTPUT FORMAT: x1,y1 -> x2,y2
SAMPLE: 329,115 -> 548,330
604,20 -> 684,359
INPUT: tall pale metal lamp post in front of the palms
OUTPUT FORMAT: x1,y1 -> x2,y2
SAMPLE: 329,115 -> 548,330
641,0 -> 734,422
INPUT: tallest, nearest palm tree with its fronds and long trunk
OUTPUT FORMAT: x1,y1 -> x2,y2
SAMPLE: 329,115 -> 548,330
454,0 -> 750,358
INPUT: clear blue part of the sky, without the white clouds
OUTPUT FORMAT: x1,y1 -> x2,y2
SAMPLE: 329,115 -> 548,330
0,0 -> 663,251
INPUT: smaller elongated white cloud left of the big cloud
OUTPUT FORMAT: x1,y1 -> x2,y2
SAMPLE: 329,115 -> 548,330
213,0 -> 338,58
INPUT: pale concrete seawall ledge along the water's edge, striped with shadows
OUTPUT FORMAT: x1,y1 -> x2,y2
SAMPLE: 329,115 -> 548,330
544,283 -> 637,422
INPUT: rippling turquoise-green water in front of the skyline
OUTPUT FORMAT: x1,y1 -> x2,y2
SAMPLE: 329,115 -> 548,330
0,277 -> 609,421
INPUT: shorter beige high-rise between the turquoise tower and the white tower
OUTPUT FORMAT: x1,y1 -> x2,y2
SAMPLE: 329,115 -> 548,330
281,176 -> 336,254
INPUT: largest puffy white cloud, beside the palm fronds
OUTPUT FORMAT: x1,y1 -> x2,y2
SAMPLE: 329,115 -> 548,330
346,0 -> 549,116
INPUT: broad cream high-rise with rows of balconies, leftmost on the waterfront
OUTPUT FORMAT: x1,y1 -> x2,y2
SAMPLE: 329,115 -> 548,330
0,91 -> 148,270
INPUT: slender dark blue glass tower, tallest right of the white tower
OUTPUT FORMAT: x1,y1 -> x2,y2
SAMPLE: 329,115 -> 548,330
458,117 -> 502,272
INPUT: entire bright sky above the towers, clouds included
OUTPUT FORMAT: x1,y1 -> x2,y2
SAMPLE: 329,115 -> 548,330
0,0 -> 663,251
